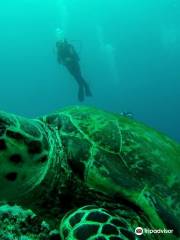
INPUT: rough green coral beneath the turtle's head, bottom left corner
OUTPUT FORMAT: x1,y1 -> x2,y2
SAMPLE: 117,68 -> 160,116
0,204 -> 60,240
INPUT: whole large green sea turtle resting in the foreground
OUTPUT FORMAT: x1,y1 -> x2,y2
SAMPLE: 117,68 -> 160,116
0,106 -> 180,240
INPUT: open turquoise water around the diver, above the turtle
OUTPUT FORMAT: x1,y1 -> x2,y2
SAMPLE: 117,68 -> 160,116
0,0 -> 180,141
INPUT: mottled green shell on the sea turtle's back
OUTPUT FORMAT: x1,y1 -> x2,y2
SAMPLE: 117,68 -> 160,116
56,106 -> 180,235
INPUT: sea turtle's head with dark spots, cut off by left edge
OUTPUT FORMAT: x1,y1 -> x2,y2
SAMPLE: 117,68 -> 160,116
0,111 -> 49,201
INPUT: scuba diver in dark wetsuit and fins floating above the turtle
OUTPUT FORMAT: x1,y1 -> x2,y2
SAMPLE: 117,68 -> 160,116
56,40 -> 92,102
